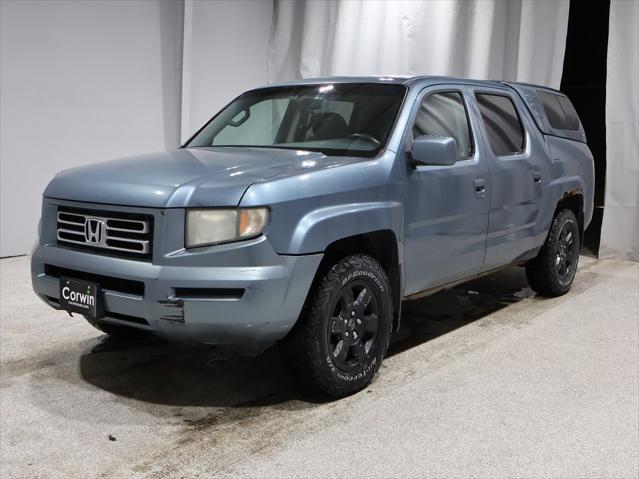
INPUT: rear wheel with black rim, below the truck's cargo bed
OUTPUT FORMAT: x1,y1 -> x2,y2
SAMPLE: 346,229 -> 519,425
526,210 -> 581,297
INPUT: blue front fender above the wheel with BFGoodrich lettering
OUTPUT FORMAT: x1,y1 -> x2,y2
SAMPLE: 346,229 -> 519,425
240,151 -> 405,255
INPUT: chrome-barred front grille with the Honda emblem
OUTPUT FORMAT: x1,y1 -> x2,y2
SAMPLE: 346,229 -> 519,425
57,208 -> 152,256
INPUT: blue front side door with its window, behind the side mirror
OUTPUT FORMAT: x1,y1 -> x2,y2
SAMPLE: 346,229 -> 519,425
404,86 -> 489,296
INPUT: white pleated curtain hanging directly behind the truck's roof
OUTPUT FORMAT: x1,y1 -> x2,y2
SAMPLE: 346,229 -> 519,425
268,0 -> 569,87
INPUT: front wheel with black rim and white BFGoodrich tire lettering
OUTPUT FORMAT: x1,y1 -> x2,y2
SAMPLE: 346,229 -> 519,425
281,255 -> 393,397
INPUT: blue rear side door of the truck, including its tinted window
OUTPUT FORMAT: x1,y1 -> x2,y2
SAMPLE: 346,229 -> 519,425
474,88 -> 548,271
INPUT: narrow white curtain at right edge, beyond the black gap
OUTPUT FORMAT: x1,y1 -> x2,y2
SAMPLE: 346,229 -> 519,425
599,0 -> 639,261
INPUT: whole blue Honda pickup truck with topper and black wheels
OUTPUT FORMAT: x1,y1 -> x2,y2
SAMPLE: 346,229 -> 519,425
32,77 -> 594,397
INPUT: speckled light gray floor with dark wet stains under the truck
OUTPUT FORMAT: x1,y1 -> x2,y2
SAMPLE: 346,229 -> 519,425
0,257 -> 639,479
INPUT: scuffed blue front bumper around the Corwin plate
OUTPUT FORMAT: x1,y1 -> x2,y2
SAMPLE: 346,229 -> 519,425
31,202 -> 322,345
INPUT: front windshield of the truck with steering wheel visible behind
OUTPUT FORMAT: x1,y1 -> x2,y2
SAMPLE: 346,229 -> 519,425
185,83 -> 406,157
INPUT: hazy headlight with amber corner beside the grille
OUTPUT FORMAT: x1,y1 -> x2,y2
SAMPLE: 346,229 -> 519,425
186,208 -> 268,248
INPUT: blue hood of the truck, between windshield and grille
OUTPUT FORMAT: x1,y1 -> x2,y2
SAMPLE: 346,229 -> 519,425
44,148 -> 331,208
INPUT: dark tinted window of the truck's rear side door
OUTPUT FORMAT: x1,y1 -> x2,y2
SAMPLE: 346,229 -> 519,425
475,93 -> 525,156
